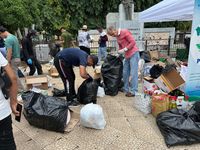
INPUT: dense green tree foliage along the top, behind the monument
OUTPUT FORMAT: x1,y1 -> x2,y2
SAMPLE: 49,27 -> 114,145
0,0 -> 191,33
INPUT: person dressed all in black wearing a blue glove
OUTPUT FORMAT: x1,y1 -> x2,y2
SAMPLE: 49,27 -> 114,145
22,30 -> 43,76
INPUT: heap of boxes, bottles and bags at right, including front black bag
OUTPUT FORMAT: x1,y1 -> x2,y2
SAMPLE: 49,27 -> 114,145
137,51 -> 200,147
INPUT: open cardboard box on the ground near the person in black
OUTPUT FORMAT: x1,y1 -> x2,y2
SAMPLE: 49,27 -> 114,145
25,75 -> 48,90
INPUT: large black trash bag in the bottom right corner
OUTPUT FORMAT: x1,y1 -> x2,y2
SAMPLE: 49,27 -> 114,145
156,102 -> 200,147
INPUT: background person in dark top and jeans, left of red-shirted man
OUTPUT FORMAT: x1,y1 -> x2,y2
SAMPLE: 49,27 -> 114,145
98,27 -> 108,65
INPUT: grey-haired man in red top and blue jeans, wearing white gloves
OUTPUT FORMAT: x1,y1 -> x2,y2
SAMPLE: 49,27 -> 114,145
107,26 -> 140,97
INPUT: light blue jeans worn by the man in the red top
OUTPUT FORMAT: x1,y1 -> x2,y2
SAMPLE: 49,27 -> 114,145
123,52 -> 140,94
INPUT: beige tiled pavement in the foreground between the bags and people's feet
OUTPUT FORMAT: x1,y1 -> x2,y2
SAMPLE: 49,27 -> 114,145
13,66 -> 200,150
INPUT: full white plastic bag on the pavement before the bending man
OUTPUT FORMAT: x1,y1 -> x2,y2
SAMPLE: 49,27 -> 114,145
80,103 -> 106,129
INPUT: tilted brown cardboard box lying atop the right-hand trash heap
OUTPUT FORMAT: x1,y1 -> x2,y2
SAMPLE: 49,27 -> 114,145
154,69 -> 185,93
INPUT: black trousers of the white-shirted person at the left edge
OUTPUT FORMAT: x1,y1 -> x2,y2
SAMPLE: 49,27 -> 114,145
0,115 -> 16,150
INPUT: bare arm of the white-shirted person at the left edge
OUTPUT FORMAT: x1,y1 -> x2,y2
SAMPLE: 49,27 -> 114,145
4,64 -> 19,116
